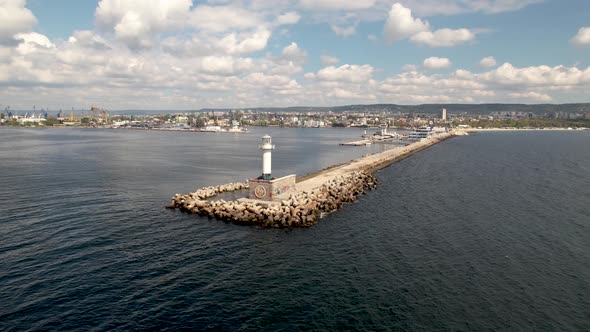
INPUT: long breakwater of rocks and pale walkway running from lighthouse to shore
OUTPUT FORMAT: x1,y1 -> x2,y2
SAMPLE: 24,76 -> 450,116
167,133 -> 456,228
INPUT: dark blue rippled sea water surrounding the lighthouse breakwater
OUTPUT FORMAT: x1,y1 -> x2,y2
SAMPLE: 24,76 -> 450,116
0,128 -> 590,331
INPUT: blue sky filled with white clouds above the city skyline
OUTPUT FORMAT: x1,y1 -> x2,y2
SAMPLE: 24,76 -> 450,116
0,0 -> 590,110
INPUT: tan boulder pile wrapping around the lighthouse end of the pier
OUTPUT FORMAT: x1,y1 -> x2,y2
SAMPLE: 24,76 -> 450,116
167,171 -> 377,228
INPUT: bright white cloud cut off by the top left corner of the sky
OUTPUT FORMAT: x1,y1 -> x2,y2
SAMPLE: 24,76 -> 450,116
0,0 -> 37,45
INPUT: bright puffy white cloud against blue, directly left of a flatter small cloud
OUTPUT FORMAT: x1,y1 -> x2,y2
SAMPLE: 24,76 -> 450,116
383,3 -> 430,42
